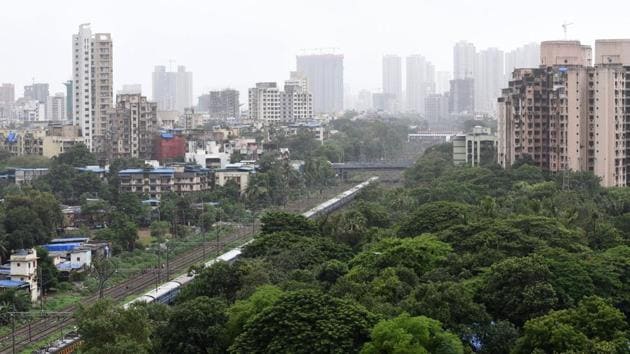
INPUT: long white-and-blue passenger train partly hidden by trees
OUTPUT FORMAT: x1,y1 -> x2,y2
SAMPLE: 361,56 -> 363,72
41,177 -> 378,354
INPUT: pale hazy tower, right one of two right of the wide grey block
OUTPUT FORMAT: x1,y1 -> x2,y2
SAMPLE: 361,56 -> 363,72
406,55 -> 435,113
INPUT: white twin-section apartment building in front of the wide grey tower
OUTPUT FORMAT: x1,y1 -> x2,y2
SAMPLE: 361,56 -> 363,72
248,79 -> 313,126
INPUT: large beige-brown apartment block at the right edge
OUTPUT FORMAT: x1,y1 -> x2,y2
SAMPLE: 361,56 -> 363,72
504,40 -> 630,186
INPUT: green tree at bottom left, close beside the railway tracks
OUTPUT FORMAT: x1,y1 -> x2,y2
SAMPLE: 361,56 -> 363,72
75,300 -> 152,354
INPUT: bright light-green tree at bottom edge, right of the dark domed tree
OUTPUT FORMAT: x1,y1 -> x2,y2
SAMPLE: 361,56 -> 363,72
361,314 -> 464,354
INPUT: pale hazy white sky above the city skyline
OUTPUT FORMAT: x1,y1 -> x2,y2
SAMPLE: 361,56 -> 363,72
0,0 -> 630,96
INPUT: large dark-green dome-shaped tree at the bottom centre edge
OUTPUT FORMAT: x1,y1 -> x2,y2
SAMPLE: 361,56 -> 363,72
230,290 -> 376,353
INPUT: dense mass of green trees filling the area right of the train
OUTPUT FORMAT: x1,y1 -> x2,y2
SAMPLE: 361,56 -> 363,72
79,142 -> 630,354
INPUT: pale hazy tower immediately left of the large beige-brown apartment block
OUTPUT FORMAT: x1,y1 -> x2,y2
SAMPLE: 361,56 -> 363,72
474,48 -> 505,115
